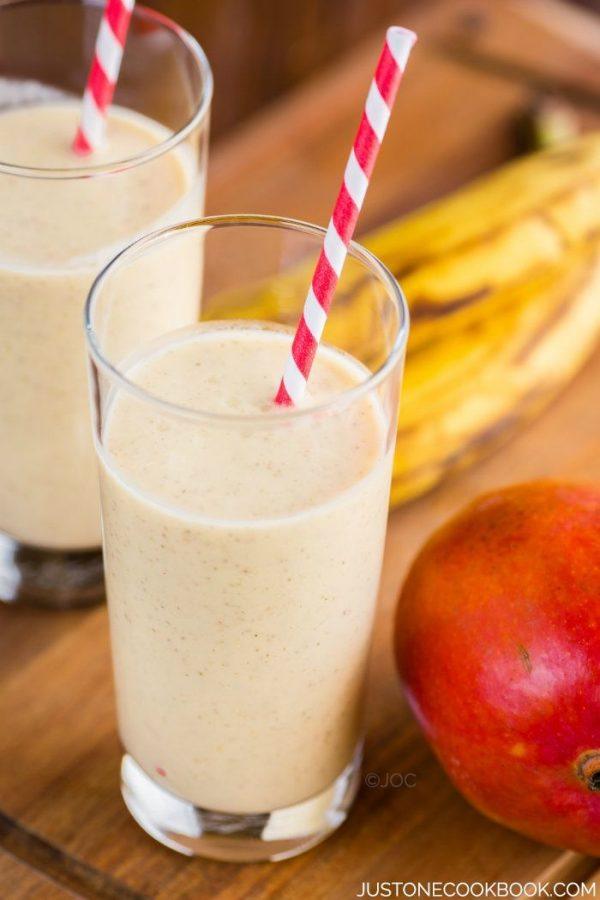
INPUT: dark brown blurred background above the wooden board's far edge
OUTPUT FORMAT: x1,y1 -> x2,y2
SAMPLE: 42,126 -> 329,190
146,0 -> 600,137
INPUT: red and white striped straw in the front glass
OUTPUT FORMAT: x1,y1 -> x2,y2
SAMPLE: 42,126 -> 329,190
275,28 -> 417,406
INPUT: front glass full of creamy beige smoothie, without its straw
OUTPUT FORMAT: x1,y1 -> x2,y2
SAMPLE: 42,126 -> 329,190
86,216 -> 408,861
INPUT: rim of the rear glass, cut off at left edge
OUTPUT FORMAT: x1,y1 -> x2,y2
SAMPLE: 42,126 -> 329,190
0,0 -> 214,180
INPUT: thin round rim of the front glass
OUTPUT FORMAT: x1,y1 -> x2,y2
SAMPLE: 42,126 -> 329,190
84,213 -> 410,424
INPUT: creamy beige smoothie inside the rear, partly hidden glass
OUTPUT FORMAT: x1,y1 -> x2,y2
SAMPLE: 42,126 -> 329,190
0,100 -> 202,550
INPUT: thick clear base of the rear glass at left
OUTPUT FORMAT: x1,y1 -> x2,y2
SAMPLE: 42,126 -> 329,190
0,533 -> 104,609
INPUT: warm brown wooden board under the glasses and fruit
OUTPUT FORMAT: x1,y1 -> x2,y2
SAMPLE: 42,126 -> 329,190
0,0 -> 600,900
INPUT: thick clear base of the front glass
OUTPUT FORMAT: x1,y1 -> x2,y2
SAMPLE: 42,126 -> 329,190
121,747 -> 362,862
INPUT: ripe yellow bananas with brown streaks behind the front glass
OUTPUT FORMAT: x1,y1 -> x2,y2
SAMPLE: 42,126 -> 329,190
205,133 -> 600,505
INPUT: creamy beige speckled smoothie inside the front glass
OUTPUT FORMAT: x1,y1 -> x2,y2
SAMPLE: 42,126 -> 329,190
98,323 -> 391,813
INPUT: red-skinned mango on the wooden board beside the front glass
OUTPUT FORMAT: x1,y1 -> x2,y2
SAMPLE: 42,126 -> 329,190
395,481 -> 600,856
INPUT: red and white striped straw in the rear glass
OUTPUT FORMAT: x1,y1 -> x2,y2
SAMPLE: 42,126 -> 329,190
73,0 -> 135,156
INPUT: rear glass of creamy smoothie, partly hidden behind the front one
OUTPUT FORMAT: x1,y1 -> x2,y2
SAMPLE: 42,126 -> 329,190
0,0 -> 212,607
